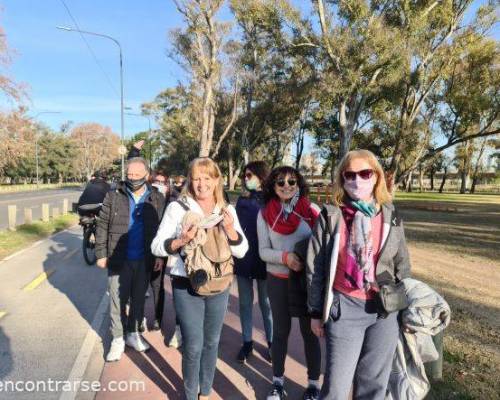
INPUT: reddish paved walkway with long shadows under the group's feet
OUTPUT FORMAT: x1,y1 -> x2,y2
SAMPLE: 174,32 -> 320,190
96,280 -> 324,400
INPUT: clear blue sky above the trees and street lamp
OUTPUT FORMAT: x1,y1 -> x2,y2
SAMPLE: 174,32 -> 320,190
0,0 -> 498,152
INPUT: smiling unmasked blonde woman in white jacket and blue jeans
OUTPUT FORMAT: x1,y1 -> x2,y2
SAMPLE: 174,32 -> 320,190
151,158 -> 248,400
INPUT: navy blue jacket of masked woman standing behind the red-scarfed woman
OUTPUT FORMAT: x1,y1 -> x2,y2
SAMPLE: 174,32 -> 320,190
234,191 -> 266,279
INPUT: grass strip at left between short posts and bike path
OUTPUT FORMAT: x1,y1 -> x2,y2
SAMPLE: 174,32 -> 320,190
0,214 -> 78,260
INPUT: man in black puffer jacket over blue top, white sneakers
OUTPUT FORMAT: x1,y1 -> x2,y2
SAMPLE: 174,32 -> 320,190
95,157 -> 165,361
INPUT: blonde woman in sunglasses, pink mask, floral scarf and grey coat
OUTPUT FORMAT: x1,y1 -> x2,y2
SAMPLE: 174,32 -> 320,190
307,150 -> 410,400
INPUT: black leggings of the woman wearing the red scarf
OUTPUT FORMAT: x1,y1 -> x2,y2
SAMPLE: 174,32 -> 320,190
267,274 -> 321,380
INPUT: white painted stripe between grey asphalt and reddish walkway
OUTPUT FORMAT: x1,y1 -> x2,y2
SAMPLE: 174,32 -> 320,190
59,293 -> 109,400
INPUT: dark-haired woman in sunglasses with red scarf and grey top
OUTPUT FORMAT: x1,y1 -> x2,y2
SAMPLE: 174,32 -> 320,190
257,166 -> 321,400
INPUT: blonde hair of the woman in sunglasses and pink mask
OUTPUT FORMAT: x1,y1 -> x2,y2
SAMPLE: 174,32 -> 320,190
333,150 -> 392,207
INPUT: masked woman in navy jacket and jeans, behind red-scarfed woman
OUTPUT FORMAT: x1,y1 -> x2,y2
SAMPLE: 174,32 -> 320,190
234,161 -> 273,363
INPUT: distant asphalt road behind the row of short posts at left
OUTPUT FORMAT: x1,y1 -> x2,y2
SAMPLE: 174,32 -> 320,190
0,188 -> 82,230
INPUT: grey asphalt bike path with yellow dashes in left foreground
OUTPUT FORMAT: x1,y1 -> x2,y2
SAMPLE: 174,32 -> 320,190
0,226 -> 108,400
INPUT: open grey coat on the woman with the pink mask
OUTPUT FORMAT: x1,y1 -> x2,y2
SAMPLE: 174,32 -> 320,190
306,203 -> 410,323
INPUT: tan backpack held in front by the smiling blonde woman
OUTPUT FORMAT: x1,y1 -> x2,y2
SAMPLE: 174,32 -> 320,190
177,200 -> 234,296
